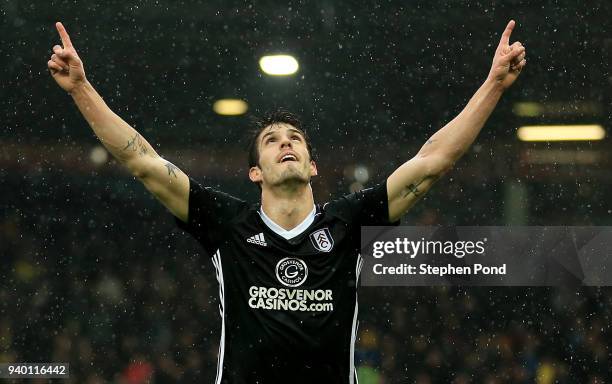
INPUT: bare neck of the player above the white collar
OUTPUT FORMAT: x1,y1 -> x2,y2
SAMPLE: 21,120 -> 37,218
261,183 -> 314,231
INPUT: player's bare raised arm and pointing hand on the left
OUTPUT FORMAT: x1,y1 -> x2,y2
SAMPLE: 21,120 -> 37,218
47,22 -> 189,221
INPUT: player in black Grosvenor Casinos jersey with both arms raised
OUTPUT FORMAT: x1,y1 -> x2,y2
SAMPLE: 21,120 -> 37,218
48,21 -> 526,383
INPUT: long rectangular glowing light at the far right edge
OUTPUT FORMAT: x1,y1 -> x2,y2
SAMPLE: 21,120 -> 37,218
516,124 -> 606,141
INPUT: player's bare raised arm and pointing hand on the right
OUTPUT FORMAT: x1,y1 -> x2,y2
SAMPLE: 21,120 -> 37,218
387,20 -> 527,222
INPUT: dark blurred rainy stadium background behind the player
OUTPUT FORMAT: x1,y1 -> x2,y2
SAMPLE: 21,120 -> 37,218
0,0 -> 612,384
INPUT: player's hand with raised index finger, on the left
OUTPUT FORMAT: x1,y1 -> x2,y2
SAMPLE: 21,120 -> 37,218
47,22 -> 87,92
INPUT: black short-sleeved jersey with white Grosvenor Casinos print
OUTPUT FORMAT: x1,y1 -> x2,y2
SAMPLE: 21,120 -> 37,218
176,178 -> 396,384
